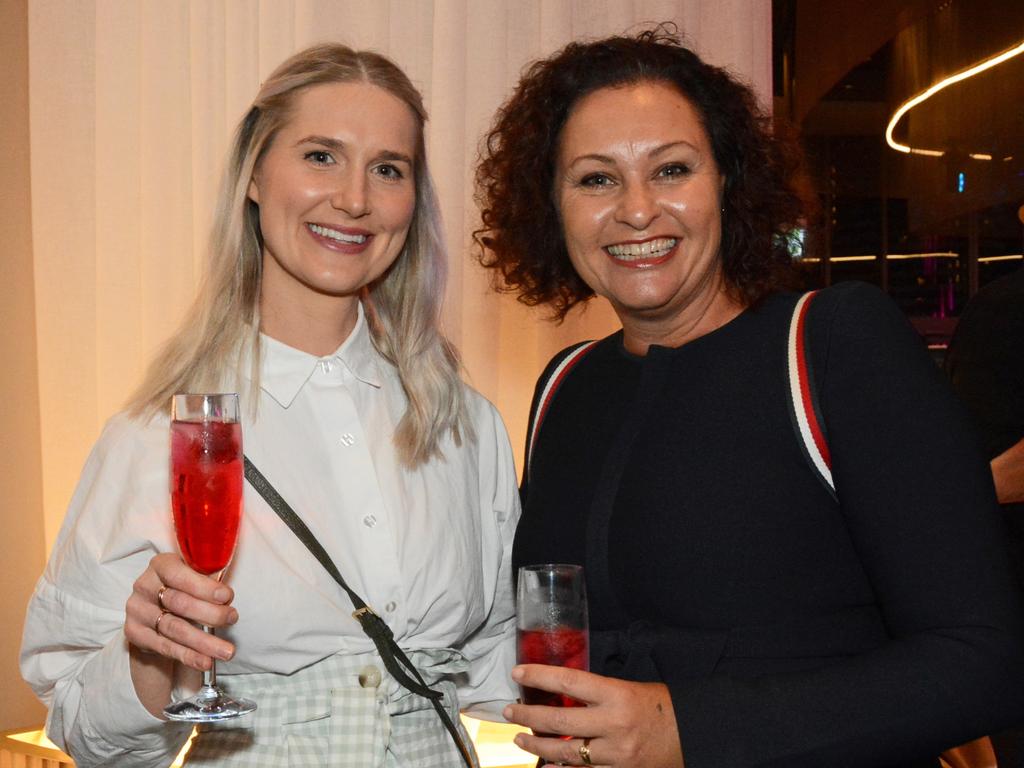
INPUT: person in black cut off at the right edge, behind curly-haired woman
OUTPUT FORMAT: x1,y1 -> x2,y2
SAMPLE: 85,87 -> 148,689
945,267 -> 1024,768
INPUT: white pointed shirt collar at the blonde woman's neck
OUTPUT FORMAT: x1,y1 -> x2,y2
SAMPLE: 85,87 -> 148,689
260,303 -> 381,408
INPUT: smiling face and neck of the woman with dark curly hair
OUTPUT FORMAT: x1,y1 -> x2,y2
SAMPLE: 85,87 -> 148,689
555,82 -> 739,352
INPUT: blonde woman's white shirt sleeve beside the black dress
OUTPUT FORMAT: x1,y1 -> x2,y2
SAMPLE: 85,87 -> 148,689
458,403 -> 519,722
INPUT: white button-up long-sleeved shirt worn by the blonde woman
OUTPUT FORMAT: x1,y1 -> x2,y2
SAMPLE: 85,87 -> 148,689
22,309 -> 519,766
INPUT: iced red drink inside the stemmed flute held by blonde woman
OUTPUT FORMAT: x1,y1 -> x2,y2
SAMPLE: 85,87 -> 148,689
171,421 -> 243,574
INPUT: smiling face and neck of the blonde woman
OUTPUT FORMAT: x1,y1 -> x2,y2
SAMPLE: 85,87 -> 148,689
249,82 -> 419,351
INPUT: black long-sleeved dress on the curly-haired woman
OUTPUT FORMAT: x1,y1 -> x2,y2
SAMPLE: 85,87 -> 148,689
514,284 -> 1024,768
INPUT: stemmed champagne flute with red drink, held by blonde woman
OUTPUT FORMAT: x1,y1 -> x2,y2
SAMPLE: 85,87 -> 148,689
164,393 -> 256,723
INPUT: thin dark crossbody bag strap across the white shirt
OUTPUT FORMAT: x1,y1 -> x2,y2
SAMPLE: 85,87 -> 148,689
245,456 -> 474,768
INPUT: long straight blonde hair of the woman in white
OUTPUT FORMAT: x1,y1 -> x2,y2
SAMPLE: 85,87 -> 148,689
128,43 -> 471,466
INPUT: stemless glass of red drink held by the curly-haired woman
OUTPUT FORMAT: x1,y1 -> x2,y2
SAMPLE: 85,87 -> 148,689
516,563 -> 590,738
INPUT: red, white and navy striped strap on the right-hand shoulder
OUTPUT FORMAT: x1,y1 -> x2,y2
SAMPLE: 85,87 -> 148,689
786,291 -> 838,499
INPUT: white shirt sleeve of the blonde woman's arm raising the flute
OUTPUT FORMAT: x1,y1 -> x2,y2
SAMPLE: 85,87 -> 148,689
20,417 -> 190,768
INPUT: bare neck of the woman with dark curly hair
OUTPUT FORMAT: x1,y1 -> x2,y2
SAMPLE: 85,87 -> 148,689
620,283 -> 744,355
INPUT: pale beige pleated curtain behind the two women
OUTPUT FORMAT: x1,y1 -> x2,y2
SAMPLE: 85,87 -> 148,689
28,0 -> 771,548
